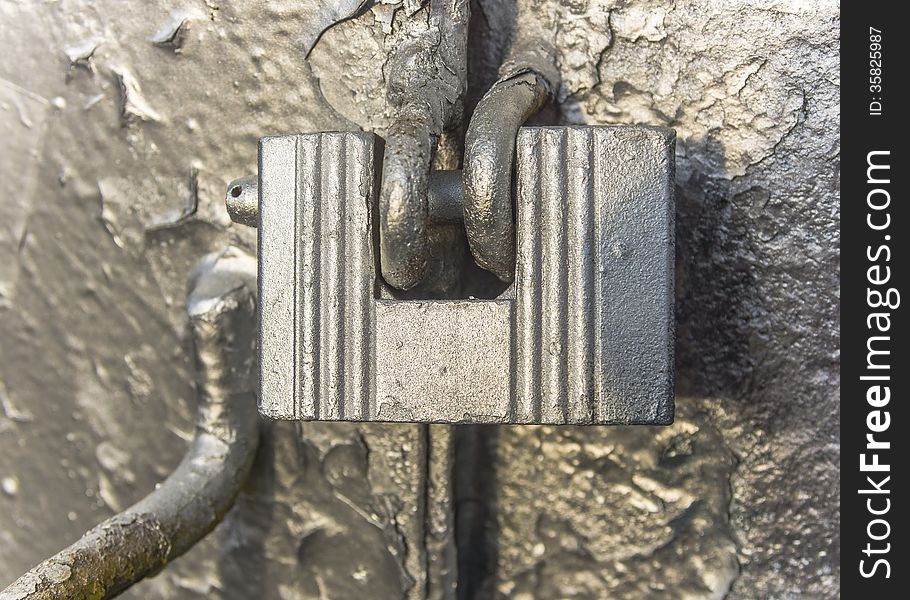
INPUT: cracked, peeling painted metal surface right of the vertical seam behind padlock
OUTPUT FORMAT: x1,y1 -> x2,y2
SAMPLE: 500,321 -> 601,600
465,0 -> 840,600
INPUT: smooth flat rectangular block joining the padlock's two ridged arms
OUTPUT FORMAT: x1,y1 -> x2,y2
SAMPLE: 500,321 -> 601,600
370,300 -> 514,423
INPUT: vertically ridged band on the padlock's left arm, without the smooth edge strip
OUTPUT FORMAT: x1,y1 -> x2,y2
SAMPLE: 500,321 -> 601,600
296,133 -> 375,420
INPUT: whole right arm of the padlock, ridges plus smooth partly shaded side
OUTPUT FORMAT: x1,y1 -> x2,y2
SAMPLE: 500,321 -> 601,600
513,127 -> 673,423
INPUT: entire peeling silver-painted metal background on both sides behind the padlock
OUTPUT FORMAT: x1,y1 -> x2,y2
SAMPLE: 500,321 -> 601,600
0,0 -> 840,600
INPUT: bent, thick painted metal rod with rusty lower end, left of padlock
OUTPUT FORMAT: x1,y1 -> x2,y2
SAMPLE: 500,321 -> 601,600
0,249 -> 259,600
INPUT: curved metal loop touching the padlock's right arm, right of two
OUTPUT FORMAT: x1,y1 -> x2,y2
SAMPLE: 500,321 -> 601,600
462,67 -> 553,282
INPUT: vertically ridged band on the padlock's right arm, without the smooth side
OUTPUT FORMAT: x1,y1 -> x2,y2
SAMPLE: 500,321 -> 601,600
515,129 -> 599,423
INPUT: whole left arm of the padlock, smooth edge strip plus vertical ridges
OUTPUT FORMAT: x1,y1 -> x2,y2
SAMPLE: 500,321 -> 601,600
259,133 -> 375,420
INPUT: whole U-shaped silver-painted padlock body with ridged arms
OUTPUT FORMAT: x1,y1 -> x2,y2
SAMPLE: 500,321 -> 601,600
258,126 -> 675,424
